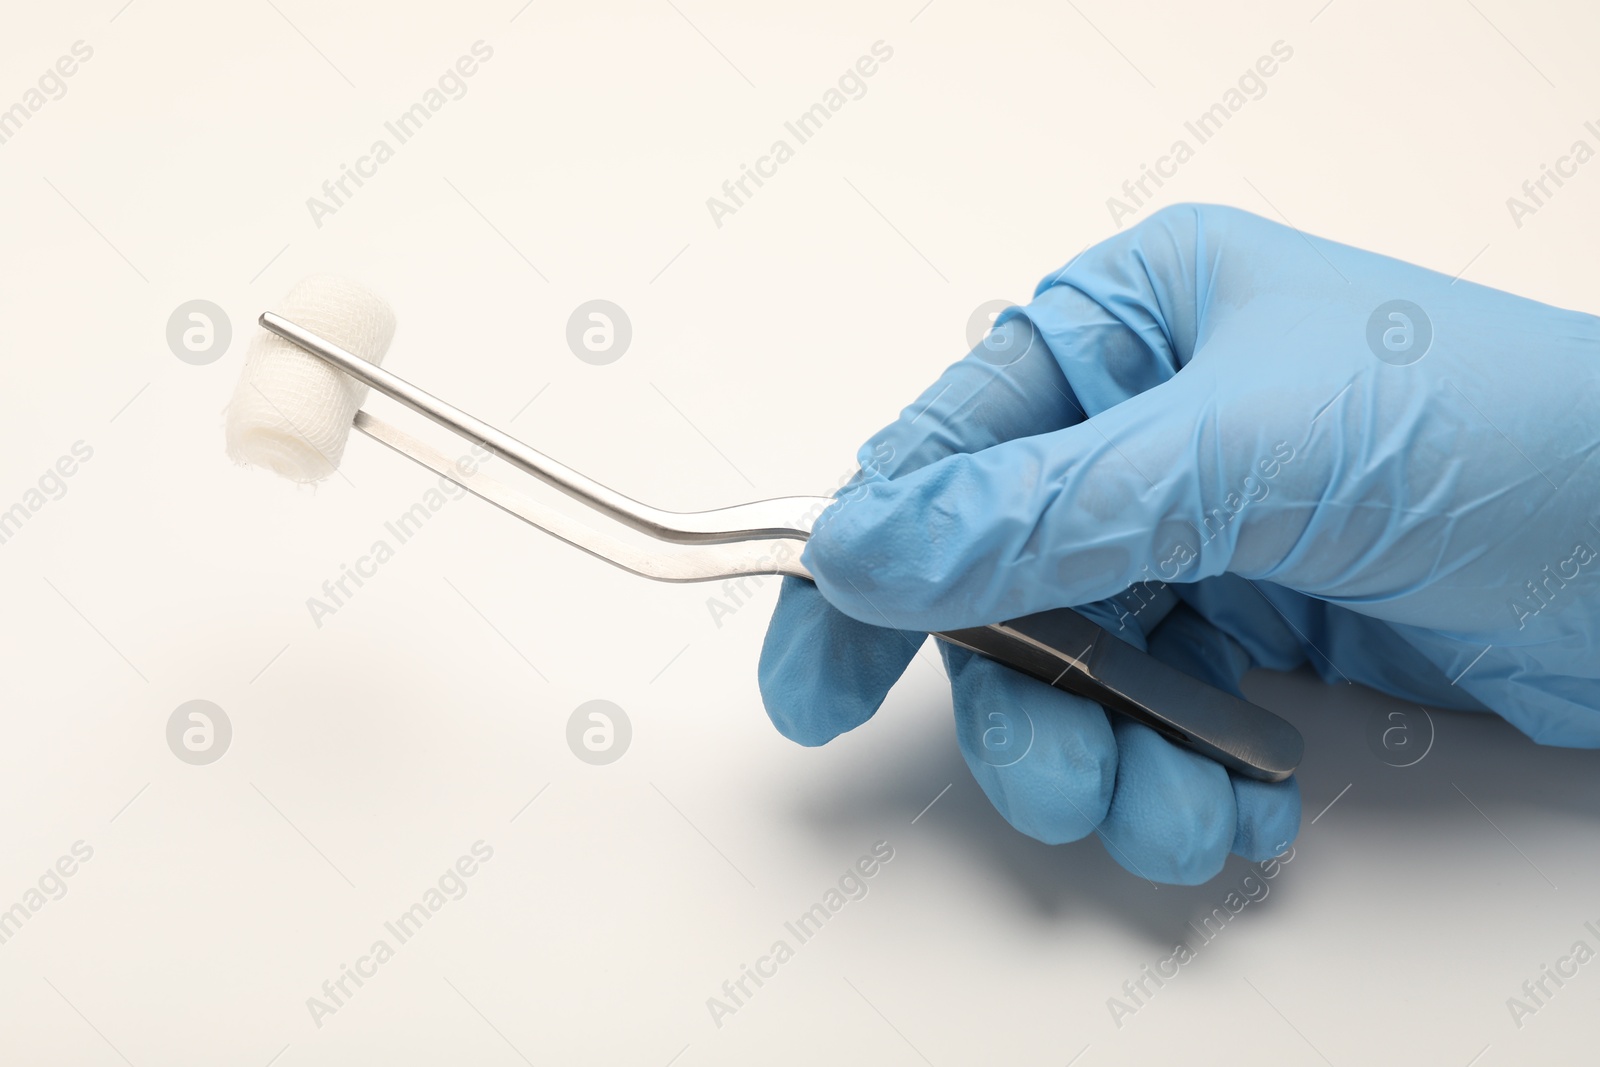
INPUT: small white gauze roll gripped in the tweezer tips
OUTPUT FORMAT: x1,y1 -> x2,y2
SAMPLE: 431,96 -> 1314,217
227,275 -> 395,482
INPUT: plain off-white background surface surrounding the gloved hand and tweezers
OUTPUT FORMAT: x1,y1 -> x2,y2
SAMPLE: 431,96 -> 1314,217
0,0 -> 1600,1067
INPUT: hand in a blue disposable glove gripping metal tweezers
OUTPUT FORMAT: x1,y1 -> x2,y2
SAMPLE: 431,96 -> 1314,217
760,205 -> 1600,883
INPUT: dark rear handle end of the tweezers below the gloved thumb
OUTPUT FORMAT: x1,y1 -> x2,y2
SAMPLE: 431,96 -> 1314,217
934,608 -> 1306,782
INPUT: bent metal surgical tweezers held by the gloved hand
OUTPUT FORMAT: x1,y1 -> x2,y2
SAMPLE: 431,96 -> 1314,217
261,312 -> 1306,782
